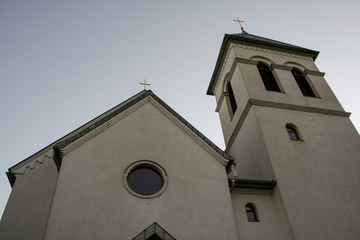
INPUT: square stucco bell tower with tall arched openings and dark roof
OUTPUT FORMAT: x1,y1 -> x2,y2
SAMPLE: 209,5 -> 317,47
207,31 -> 360,239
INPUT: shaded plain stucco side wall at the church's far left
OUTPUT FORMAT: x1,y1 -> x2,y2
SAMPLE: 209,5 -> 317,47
0,158 -> 58,240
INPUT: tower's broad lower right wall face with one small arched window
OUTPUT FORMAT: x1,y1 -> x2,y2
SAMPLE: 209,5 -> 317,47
256,107 -> 360,240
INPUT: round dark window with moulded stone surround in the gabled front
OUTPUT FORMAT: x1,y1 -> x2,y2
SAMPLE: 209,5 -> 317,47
125,161 -> 166,198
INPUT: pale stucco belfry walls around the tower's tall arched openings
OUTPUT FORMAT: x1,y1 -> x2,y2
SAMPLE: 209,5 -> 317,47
215,43 -> 343,145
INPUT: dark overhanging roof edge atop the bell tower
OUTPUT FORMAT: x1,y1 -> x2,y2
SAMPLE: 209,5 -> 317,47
206,31 -> 319,95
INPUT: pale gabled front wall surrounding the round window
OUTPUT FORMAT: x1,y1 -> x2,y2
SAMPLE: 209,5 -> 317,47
45,103 -> 237,240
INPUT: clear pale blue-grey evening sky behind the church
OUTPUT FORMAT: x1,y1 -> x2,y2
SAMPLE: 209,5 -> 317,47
0,0 -> 360,218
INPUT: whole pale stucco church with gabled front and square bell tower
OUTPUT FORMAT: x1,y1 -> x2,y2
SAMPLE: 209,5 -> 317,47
0,30 -> 360,240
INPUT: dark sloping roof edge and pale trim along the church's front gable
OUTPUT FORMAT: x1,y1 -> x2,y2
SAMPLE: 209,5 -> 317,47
7,90 -> 234,186
